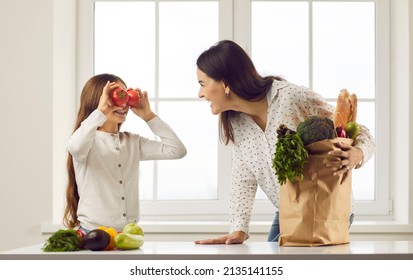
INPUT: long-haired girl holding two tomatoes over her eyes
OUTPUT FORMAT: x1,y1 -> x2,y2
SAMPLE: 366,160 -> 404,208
63,74 -> 186,233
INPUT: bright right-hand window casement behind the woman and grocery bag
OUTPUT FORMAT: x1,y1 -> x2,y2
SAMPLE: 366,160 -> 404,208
246,0 -> 389,214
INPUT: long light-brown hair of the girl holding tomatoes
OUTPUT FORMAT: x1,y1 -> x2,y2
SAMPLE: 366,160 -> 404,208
63,74 -> 126,228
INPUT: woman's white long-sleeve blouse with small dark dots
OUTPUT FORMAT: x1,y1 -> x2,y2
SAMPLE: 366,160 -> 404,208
230,81 -> 375,233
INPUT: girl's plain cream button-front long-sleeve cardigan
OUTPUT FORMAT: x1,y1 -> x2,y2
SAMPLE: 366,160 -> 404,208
67,110 -> 186,231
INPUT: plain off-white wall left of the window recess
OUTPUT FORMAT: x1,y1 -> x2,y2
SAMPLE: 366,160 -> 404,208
0,0 -> 53,251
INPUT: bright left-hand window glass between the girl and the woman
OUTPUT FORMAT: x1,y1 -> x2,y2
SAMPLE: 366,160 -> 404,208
94,1 -> 219,201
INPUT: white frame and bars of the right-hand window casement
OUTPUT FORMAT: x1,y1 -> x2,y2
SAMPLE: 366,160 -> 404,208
234,0 -> 393,215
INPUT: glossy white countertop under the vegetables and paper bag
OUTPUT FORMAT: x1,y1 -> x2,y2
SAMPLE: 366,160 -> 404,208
0,241 -> 413,260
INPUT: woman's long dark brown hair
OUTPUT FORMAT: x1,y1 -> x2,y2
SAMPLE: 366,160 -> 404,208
196,40 -> 283,144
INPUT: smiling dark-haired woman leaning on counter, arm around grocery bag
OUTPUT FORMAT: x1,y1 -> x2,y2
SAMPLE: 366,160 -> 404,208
195,40 -> 375,244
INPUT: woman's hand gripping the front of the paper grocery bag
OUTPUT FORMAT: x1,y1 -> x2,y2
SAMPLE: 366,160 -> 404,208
325,142 -> 363,175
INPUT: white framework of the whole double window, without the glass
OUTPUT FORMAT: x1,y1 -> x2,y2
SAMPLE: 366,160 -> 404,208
63,0 -> 391,221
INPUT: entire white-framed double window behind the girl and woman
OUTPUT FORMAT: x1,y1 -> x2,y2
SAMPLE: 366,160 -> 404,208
72,0 -> 389,221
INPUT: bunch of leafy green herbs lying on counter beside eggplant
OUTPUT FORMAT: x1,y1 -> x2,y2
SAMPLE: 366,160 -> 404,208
43,229 -> 82,252
